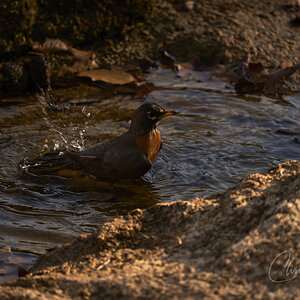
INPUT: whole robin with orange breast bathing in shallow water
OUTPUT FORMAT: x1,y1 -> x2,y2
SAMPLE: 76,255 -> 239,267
27,103 -> 176,180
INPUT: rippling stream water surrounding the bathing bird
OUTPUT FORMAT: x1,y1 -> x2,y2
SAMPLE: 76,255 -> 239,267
0,70 -> 300,281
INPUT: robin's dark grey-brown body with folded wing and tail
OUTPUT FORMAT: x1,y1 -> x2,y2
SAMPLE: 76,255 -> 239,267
24,135 -> 152,179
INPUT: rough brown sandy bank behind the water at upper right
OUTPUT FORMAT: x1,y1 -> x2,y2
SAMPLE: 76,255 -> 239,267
105,0 -> 300,68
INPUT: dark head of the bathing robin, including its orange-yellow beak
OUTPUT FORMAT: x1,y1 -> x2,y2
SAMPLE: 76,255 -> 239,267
130,103 -> 176,132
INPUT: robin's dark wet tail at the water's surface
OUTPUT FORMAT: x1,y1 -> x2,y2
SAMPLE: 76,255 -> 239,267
21,152 -> 72,175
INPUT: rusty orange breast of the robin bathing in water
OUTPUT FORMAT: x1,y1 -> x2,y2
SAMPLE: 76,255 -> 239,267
136,129 -> 161,162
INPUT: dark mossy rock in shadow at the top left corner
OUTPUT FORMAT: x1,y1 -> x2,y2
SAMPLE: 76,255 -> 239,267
0,0 -> 152,58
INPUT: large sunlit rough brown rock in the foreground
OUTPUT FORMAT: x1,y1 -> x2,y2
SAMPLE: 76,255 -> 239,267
0,161 -> 300,299
